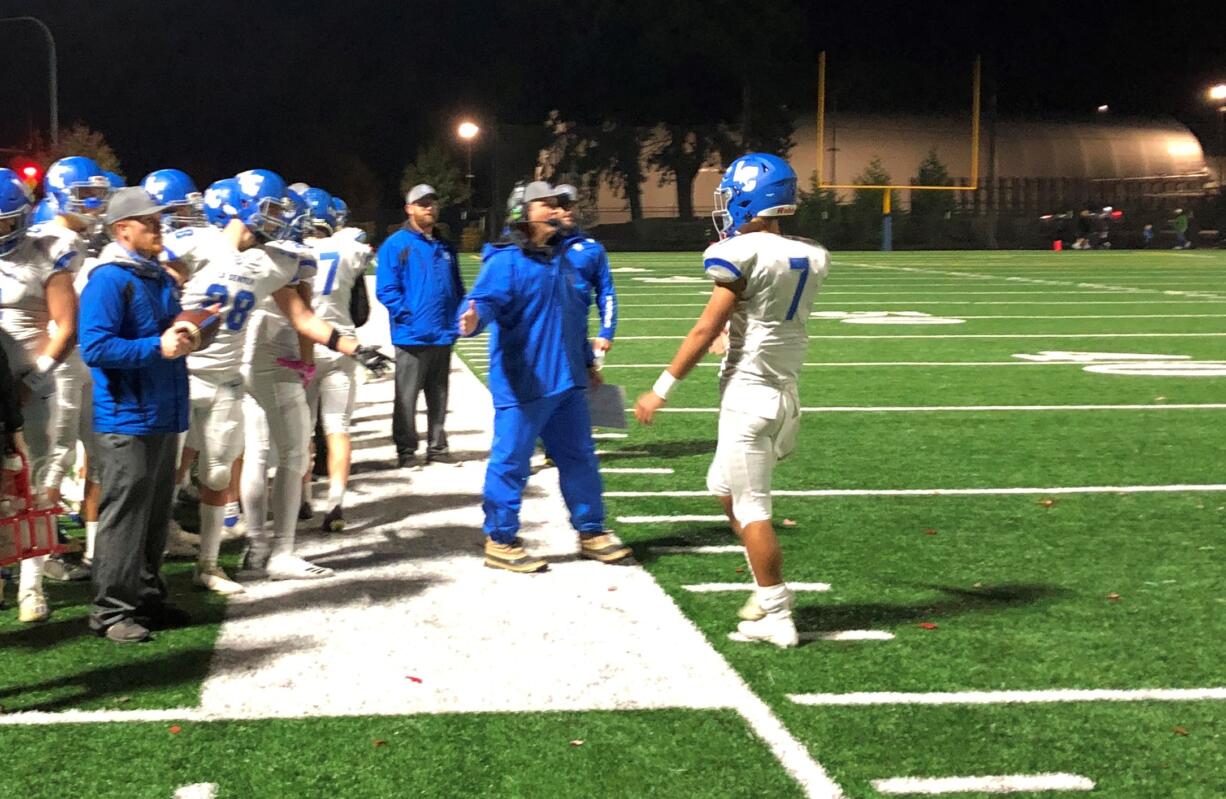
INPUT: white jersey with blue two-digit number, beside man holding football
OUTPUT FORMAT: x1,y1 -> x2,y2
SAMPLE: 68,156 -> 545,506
181,237 -> 311,382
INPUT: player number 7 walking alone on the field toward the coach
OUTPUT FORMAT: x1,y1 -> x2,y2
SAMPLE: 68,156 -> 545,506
634,153 -> 830,647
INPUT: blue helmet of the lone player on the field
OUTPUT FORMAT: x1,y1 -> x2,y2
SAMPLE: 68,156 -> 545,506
711,153 -> 796,239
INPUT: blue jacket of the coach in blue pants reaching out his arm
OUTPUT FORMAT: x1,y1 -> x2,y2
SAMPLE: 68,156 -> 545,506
462,234 -> 592,408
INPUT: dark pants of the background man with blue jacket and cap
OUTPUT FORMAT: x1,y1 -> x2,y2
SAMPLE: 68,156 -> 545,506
391,344 -> 451,458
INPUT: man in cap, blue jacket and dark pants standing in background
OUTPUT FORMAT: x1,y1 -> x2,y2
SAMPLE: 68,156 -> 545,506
375,184 -> 463,467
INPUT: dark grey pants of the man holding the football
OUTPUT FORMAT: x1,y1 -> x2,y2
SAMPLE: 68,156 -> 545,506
89,433 -> 179,630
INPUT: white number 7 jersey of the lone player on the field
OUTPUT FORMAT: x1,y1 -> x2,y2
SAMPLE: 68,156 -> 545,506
702,232 -> 830,388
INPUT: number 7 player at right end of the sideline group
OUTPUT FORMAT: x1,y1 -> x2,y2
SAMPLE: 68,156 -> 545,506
304,189 -> 371,533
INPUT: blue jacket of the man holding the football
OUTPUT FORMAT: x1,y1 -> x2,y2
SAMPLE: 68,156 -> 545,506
77,243 -> 189,435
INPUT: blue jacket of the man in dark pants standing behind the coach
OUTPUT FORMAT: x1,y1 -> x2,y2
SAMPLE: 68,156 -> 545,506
375,227 -> 463,347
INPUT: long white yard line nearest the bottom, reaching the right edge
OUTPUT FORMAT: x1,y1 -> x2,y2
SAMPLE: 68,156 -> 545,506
787,687 -> 1226,707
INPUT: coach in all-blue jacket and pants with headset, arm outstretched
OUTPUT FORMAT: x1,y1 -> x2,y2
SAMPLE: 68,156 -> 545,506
460,181 -> 630,572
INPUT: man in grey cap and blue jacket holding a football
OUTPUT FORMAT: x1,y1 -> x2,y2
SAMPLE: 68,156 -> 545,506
78,186 -> 191,643
